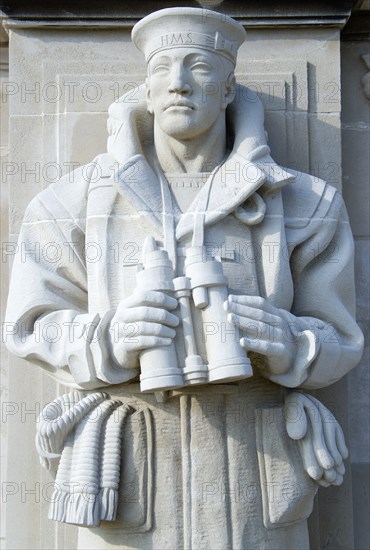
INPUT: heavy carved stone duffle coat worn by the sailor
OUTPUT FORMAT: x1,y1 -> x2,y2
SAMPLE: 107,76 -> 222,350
7,135 -> 362,550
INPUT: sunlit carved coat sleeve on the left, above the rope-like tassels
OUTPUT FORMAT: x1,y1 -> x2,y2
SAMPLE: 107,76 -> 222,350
3,166 -> 137,389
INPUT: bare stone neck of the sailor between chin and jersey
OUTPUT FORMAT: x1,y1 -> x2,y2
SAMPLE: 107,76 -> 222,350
154,117 -> 226,173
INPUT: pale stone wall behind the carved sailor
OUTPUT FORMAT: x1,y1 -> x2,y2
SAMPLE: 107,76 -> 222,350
2,2 -> 369,550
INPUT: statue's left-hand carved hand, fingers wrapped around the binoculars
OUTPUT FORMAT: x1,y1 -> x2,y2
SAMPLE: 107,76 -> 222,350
109,290 -> 179,368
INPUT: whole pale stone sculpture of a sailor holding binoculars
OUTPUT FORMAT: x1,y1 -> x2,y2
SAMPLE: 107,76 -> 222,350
7,8 -> 362,550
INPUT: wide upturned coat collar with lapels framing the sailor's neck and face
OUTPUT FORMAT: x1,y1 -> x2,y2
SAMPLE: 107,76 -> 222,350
107,85 -> 294,239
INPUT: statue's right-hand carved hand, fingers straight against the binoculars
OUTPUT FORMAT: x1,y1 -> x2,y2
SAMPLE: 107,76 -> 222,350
224,294 -> 297,374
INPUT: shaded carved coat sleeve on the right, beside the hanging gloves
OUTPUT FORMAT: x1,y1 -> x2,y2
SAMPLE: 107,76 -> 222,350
270,186 -> 363,389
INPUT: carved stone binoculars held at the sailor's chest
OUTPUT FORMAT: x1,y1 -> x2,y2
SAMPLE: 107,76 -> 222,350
137,237 -> 253,392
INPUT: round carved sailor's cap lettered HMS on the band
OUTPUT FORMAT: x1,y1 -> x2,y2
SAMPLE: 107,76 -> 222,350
131,8 -> 245,64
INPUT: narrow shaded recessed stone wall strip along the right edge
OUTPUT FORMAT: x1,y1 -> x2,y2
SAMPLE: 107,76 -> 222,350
341,2 -> 370,548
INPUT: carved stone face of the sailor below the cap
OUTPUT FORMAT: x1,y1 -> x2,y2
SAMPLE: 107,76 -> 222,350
147,48 -> 233,140
